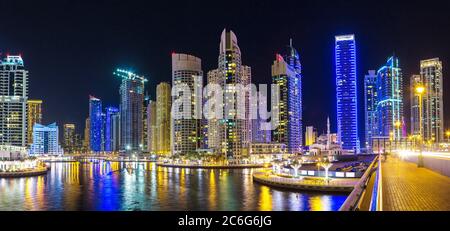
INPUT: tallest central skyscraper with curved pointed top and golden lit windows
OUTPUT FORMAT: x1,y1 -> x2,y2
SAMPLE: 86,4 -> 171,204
208,29 -> 251,160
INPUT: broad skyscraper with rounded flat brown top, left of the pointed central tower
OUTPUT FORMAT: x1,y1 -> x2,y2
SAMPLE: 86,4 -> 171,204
171,53 -> 203,154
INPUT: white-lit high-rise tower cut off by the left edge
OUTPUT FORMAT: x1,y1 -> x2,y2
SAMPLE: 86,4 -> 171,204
0,55 -> 28,146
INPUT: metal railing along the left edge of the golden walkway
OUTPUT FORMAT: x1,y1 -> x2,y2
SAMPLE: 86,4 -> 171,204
339,155 -> 382,211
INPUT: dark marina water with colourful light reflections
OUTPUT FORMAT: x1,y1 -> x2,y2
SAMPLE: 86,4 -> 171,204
0,161 -> 347,211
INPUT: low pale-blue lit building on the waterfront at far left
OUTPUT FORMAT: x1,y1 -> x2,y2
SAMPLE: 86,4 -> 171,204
30,123 -> 64,156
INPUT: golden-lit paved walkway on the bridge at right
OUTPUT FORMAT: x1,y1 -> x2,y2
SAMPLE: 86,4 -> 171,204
381,156 -> 450,211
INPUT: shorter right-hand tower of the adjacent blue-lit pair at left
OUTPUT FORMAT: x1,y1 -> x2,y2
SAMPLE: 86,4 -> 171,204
105,107 -> 120,152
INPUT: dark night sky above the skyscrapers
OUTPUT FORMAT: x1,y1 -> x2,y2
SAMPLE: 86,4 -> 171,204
0,0 -> 450,141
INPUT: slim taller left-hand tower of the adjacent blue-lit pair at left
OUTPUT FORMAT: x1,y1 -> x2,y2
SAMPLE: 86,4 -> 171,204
89,96 -> 103,152
